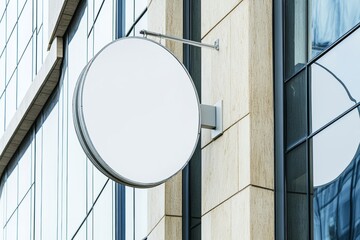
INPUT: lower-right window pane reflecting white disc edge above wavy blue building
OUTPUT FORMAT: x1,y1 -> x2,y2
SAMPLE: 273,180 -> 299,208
310,109 -> 360,240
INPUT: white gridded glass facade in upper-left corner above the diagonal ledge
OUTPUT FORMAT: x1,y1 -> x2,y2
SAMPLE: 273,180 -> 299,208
0,0 -> 48,139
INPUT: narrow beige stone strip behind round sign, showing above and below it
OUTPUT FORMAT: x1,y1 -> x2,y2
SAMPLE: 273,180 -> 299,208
147,0 -> 183,240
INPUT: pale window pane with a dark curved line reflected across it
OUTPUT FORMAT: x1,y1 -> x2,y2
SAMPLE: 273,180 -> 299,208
311,29 -> 360,132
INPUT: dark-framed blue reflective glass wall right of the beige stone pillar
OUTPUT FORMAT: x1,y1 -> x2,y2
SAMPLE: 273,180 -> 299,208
283,0 -> 360,239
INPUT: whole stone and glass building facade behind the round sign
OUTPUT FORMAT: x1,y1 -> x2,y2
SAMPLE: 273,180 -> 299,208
0,0 -> 360,240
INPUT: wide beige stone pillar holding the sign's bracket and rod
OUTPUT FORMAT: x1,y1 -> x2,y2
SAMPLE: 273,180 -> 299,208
201,0 -> 274,239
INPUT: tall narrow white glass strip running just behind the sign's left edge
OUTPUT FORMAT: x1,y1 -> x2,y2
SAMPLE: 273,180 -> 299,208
67,7 -> 87,236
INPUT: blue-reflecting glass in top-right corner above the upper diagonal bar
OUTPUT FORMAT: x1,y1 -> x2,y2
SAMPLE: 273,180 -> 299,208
284,0 -> 360,78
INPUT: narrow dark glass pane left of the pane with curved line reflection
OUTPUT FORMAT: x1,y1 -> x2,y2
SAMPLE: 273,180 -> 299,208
285,70 -> 307,146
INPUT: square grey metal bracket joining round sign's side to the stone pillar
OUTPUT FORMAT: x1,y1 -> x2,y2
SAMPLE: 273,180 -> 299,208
200,100 -> 223,139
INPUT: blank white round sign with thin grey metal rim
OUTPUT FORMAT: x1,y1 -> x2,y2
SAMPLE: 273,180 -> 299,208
73,38 -> 200,188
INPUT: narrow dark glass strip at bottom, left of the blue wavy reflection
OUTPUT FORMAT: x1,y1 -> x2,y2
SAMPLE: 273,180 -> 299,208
285,143 -> 308,240
